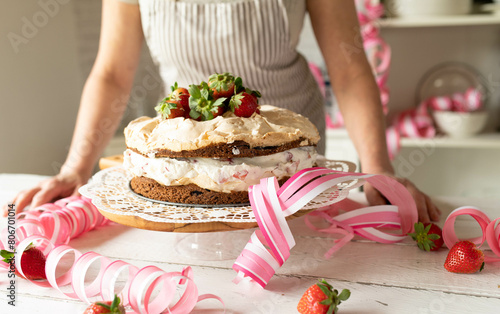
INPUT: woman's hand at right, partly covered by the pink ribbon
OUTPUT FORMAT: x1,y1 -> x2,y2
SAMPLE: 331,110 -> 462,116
364,173 -> 441,223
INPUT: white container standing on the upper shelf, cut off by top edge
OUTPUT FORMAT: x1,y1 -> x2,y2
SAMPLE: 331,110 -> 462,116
385,0 -> 473,17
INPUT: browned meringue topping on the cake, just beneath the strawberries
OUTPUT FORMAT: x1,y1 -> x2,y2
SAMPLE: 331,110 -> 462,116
124,105 -> 320,155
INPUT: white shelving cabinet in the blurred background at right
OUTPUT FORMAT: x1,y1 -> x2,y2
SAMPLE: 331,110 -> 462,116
309,15 -> 500,198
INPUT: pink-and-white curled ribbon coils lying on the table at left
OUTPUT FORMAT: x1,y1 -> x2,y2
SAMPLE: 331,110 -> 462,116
0,197 -> 224,313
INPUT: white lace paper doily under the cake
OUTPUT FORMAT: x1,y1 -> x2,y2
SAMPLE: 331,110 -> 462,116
79,160 -> 360,228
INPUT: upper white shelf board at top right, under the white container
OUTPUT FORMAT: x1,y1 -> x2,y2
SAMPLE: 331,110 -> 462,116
380,14 -> 500,28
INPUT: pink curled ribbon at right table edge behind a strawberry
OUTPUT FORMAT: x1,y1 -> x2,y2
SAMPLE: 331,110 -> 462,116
443,206 -> 500,263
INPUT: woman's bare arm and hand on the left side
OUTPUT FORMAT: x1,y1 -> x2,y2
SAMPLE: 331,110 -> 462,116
7,0 -> 143,212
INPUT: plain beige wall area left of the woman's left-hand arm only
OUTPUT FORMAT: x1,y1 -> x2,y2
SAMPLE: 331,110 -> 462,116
0,0 -> 82,174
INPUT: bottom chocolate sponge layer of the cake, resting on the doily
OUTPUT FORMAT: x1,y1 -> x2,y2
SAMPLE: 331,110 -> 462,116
130,177 -> 288,205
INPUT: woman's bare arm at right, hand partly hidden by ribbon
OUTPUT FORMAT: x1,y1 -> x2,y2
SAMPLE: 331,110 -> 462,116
307,0 -> 439,222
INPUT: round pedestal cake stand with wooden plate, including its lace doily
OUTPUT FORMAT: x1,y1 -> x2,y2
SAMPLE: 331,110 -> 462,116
79,160 -> 355,260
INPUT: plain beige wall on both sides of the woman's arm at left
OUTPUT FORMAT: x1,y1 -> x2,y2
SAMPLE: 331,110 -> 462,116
0,0 -> 161,175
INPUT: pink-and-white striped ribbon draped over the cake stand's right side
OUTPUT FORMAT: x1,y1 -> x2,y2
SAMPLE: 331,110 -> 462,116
233,168 -> 418,287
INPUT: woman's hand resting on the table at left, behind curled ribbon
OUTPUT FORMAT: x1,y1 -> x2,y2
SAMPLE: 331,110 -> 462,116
3,172 -> 88,217
